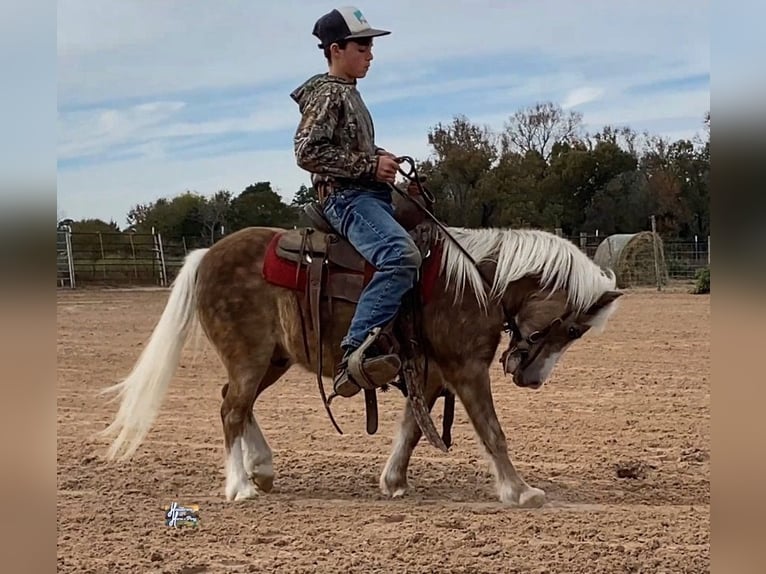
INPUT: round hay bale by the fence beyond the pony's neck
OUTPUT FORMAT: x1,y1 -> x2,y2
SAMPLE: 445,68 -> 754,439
593,231 -> 668,289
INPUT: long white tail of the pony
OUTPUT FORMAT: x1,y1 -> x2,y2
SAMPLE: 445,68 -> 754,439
99,249 -> 212,459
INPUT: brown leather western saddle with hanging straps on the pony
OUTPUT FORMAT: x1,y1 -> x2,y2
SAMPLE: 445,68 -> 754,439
276,193 -> 455,451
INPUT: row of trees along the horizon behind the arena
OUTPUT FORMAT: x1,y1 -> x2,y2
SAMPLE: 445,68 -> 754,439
111,102 -> 710,244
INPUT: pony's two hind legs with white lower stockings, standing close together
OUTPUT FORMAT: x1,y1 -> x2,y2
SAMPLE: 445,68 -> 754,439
221,353 -> 290,500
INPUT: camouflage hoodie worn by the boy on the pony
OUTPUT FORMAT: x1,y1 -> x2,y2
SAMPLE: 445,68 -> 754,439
290,73 -> 380,195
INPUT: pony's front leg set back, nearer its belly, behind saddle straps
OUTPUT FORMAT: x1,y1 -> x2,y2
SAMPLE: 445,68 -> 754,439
380,376 -> 442,498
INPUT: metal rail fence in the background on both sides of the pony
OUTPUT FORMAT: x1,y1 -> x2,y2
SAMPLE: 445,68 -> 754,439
56,226 -> 710,288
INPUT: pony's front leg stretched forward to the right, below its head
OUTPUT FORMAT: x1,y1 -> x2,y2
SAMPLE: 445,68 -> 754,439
455,367 -> 545,508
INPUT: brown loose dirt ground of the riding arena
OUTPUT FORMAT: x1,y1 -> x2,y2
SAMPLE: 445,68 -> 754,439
57,290 -> 710,574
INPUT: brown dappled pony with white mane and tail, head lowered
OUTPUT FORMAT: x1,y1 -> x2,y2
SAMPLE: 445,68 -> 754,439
100,212 -> 621,508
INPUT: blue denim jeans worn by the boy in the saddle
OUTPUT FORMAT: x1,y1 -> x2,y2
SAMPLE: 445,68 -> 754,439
324,189 -> 422,349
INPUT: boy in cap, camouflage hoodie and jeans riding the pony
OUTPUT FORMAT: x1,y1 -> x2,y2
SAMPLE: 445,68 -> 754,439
291,7 -> 421,404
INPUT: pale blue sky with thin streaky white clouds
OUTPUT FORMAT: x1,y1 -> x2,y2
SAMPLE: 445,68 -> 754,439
57,0 -> 711,227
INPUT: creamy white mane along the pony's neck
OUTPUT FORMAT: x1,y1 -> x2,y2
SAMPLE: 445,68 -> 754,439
441,228 -> 616,312
